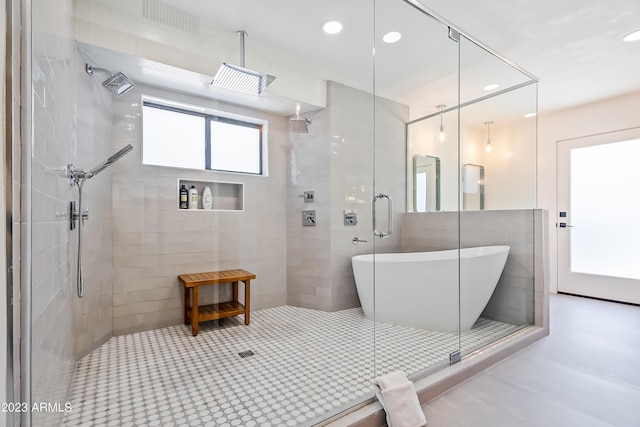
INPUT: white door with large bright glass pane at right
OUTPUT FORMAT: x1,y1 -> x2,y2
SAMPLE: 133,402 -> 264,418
556,128 -> 640,304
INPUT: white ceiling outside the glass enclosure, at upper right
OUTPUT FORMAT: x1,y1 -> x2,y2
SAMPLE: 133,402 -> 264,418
420,0 -> 640,112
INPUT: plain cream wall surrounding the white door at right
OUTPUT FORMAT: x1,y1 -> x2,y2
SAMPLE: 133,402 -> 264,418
538,92 -> 640,292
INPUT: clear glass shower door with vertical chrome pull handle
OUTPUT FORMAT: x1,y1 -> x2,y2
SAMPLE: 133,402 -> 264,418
372,1 -> 459,378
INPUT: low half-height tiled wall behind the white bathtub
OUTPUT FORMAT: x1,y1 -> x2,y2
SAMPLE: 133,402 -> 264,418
403,209 -> 547,325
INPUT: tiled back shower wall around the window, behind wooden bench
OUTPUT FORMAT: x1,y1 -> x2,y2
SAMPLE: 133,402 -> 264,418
113,85 -> 287,335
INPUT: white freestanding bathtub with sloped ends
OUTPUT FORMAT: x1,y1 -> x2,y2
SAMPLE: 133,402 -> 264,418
351,246 -> 509,332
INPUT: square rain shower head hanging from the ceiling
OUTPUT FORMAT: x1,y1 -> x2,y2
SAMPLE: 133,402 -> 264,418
211,31 -> 275,95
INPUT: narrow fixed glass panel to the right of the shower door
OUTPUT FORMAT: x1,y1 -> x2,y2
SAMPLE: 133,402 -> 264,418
459,37 -> 537,354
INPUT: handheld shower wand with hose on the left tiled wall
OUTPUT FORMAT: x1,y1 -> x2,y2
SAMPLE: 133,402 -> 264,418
67,144 -> 133,298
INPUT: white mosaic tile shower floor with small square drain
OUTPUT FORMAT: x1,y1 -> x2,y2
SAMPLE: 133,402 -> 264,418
63,306 -> 518,427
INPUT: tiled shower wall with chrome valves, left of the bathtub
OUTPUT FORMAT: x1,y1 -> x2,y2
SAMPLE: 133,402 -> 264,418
287,82 -> 409,311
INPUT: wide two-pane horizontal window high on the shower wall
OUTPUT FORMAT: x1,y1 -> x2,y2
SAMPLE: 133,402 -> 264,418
142,101 -> 263,175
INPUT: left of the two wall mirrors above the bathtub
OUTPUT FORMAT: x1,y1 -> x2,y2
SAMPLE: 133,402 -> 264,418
413,154 -> 440,212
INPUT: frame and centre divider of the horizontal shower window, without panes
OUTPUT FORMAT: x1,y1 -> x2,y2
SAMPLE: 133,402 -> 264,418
142,98 -> 267,176
